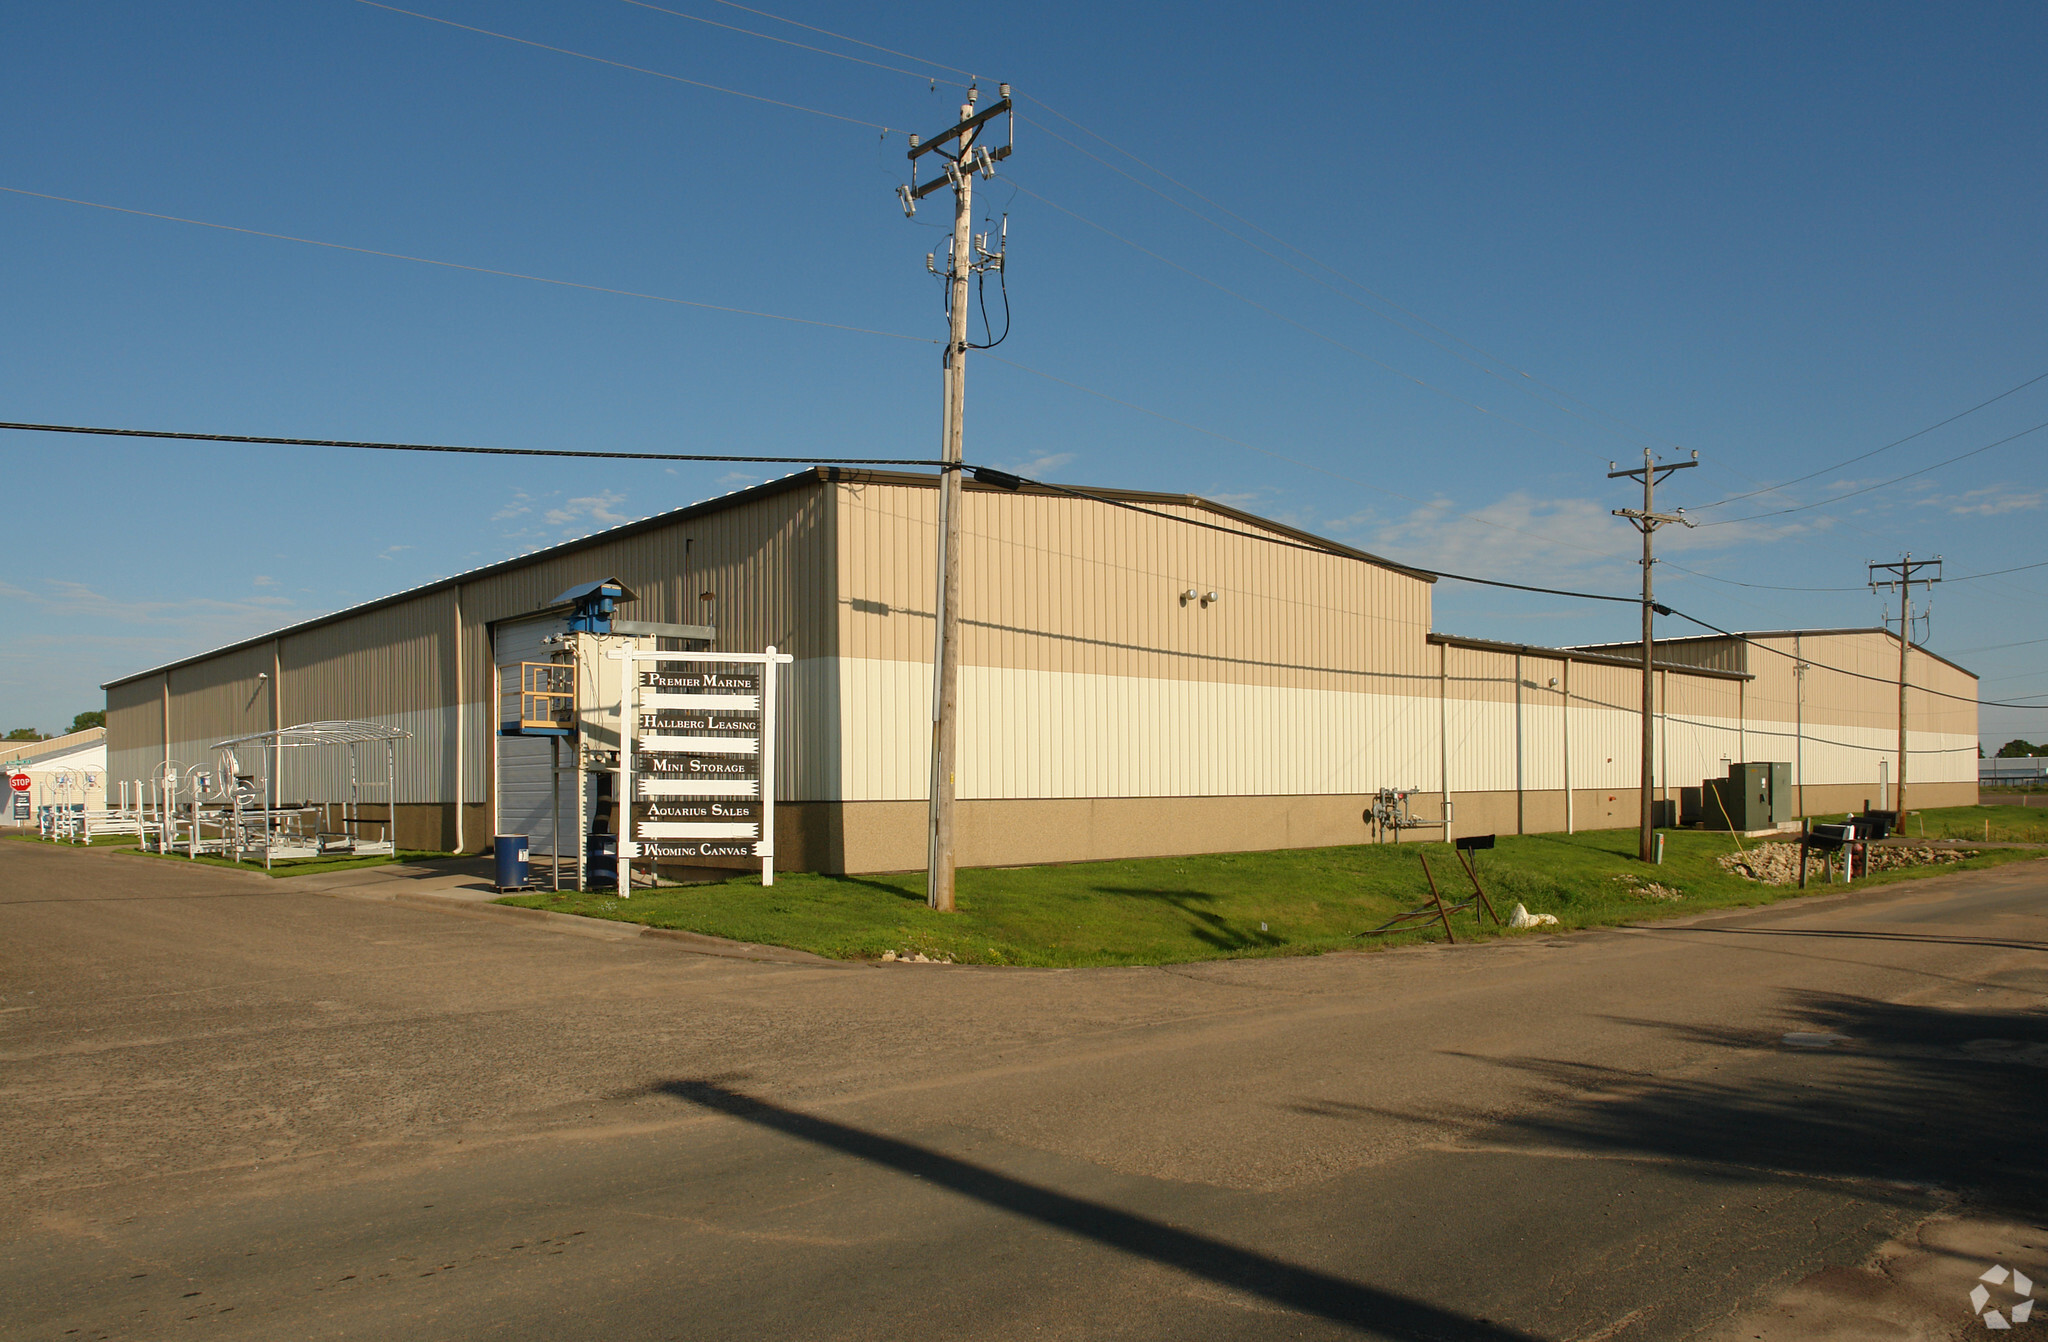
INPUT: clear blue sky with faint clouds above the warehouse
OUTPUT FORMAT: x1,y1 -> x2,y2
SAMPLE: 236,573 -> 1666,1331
0,0 -> 2048,746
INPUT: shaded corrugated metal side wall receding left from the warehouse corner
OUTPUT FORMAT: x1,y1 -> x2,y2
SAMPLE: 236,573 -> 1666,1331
109,486 -> 836,819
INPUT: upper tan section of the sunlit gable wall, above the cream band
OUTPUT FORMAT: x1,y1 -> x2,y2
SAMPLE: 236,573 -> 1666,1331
838,484 -> 1434,695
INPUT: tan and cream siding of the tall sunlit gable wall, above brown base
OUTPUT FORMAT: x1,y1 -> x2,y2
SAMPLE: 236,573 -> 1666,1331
838,484 -> 1436,801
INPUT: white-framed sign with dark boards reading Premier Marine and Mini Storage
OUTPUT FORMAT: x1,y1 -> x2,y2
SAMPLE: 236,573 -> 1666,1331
618,647 -> 795,897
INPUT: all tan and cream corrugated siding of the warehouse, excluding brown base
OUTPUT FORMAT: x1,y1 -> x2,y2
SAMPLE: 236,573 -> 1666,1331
109,475 -> 1976,840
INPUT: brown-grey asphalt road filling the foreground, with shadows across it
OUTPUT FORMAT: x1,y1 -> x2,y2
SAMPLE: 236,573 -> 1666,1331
0,842 -> 2048,1342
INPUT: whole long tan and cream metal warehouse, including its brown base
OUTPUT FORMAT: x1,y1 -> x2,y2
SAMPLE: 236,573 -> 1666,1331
106,469 -> 1976,873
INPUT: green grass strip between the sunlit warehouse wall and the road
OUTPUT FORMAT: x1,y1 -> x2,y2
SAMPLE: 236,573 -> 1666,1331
500,807 -> 2048,965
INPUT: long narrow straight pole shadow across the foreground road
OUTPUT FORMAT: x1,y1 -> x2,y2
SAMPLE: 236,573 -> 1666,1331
649,1080 -> 1530,1342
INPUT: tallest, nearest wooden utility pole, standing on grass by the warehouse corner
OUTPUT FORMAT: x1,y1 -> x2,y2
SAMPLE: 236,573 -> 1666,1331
897,84 -> 1012,914
